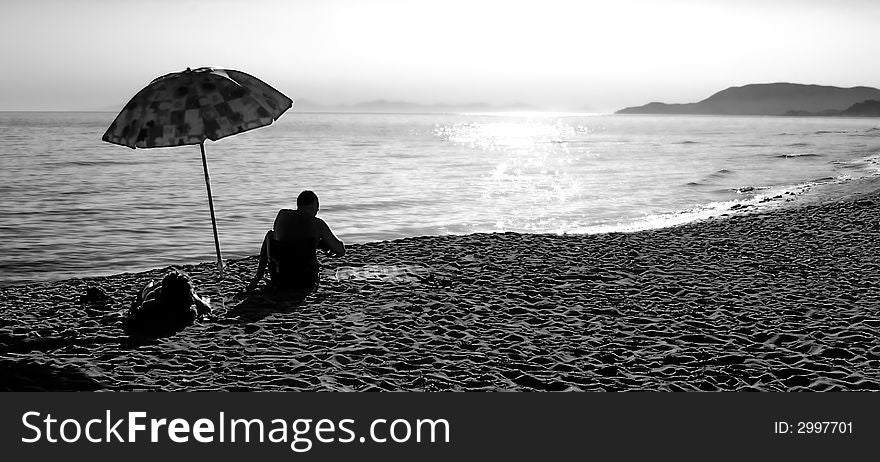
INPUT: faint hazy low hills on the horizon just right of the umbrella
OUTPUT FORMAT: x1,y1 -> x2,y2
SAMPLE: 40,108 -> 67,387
294,99 -> 541,113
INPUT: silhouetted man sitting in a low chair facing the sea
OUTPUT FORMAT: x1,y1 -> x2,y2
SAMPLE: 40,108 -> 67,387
246,191 -> 345,292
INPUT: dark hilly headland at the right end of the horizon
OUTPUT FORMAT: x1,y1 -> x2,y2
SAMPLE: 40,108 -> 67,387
616,83 -> 880,117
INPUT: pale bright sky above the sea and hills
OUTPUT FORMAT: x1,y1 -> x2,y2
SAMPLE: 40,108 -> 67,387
0,0 -> 880,112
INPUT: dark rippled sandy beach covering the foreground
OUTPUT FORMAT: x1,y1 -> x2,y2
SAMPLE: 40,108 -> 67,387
0,184 -> 880,390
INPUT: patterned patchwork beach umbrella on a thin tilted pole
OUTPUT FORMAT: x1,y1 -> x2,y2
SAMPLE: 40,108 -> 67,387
103,67 -> 293,274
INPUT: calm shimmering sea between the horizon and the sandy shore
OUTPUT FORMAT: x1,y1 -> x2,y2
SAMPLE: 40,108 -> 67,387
0,111 -> 880,286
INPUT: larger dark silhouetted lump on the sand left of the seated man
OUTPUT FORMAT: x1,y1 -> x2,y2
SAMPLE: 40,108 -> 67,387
126,269 -> 211,331
